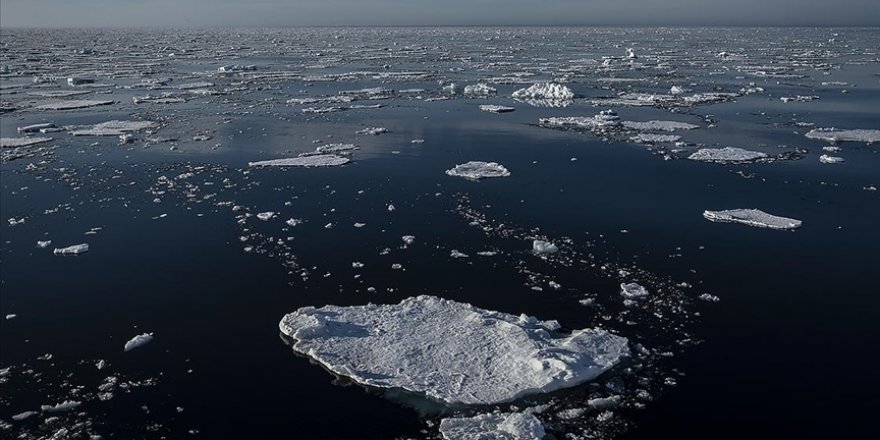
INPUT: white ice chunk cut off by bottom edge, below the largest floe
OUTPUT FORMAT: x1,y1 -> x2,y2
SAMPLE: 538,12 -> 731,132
440,413 -> 545,440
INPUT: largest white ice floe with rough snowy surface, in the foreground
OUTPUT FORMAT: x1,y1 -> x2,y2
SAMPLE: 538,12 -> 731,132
279,295 -> 629,404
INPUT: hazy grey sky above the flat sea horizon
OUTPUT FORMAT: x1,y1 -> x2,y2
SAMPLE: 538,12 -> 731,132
0,0 -> 880,27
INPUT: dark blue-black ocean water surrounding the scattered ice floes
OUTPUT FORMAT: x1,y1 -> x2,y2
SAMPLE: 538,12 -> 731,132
0,29 -> 880,439
